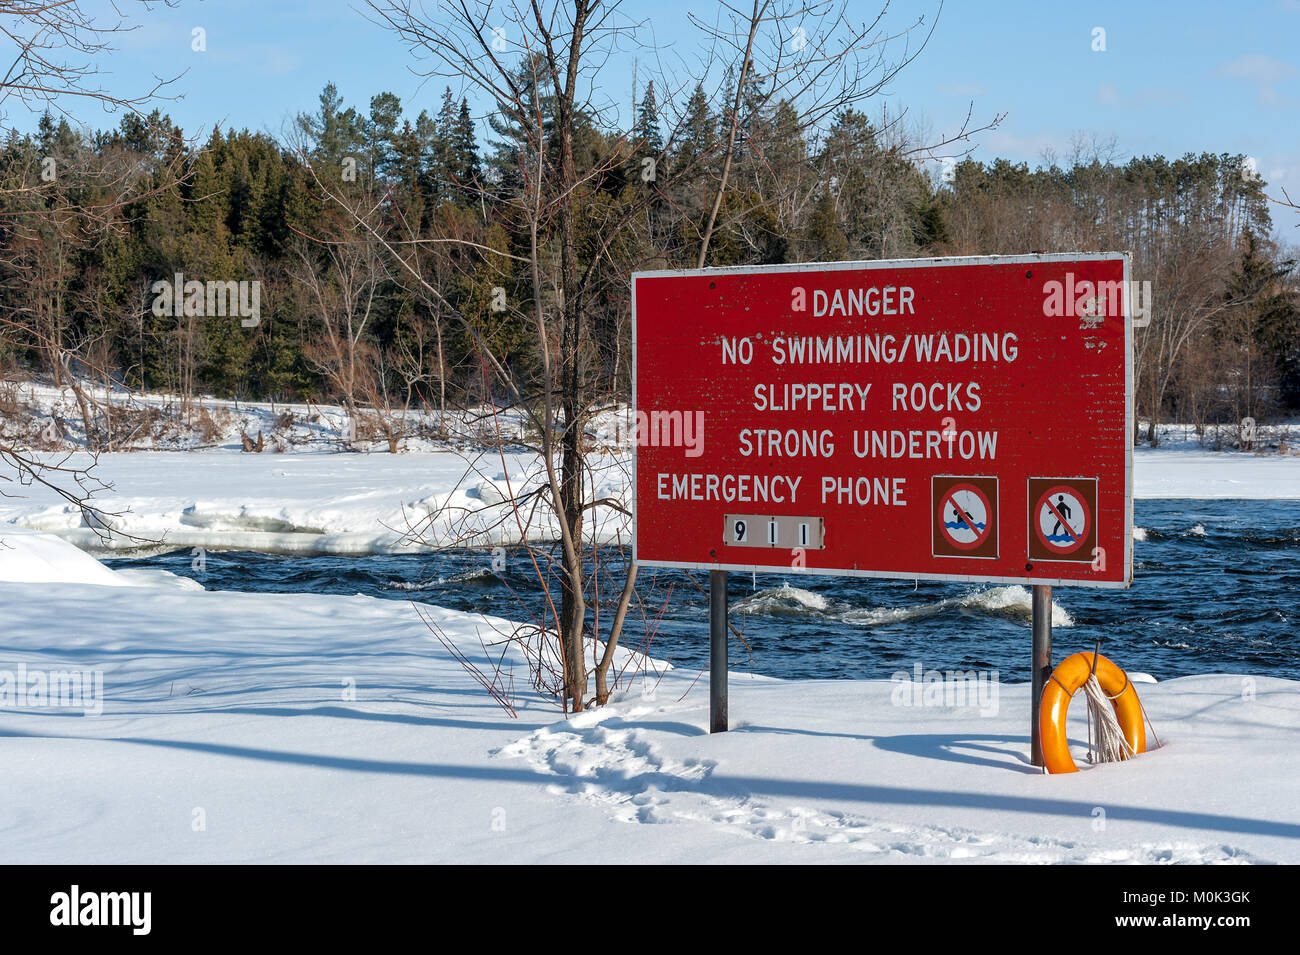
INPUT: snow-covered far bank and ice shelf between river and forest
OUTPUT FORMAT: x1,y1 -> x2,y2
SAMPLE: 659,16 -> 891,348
0,385 -> 1300,554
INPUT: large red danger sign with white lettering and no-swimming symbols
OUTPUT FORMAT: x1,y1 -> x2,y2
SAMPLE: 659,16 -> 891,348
632,253 -> 1132,587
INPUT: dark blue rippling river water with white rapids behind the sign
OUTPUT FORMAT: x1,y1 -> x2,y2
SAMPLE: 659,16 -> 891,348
107,500 -> 1300,682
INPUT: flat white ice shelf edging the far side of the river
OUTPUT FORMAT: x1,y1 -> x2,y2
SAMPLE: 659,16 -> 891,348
0,450 -> 1300,554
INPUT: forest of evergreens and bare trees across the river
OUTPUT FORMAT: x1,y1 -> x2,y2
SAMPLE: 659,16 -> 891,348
0,84 -> 1300,438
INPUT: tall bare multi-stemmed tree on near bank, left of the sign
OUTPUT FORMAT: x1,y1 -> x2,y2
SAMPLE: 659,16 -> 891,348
343,0 -> 993,711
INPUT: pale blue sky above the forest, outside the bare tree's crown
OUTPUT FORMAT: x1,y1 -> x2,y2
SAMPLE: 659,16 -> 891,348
35,0 -> 1300,231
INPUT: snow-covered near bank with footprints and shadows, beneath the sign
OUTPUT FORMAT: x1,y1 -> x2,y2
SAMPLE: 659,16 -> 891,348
0,531 -> 1300,864
